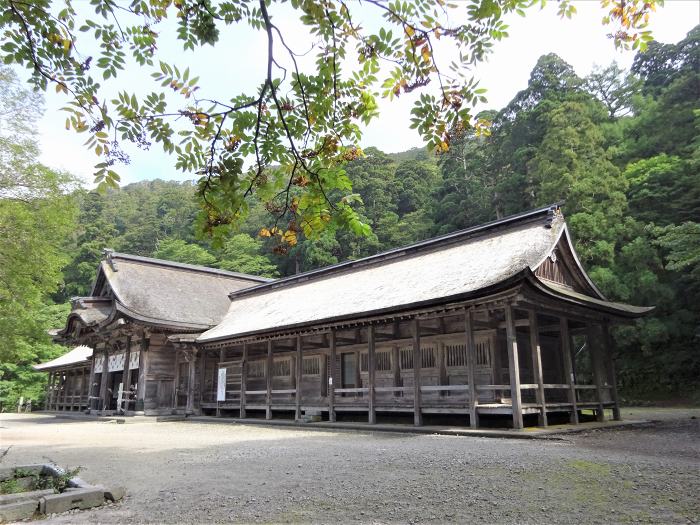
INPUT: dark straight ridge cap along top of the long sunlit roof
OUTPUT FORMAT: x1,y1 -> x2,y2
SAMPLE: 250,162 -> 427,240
229,201 -> 563,299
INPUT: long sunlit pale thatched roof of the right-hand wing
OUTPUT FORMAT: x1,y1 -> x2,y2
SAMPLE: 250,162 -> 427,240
198,206 -> 646,343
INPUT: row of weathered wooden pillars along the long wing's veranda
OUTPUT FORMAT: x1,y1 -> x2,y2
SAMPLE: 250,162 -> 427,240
227,304 -> 620,429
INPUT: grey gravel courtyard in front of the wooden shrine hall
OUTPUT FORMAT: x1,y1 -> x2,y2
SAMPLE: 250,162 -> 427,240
0,409 -> 700,524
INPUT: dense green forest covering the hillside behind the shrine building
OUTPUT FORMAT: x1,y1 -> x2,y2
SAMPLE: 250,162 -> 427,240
0,26 -> 700,404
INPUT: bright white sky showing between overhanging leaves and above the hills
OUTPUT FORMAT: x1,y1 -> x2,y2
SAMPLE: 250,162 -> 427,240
28,0 -> 700,186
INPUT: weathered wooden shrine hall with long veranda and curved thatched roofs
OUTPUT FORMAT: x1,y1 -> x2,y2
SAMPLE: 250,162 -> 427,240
38,206 -> 650,428
